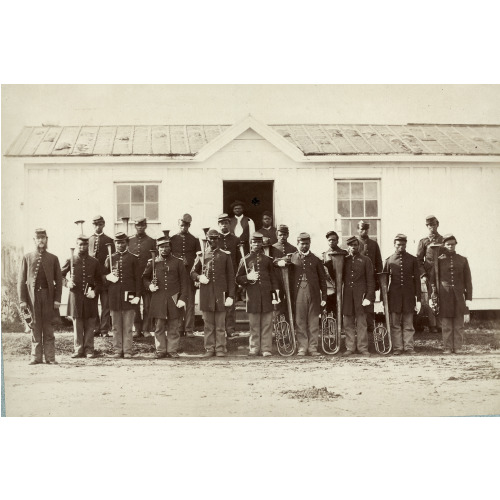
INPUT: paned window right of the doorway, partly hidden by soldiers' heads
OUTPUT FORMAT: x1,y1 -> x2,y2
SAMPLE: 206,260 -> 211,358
335,180 -> 380,248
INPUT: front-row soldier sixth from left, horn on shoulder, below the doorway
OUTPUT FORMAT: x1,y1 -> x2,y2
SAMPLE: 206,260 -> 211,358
236,233 -> 279,356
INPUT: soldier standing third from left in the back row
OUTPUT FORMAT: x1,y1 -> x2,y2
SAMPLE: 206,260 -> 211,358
170,214 -> 201,337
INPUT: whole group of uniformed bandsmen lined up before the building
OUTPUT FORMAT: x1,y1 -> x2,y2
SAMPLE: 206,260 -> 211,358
18,201 -> 472,364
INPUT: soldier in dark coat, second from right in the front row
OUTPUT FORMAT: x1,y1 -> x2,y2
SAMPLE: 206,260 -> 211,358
384,234 -> 421,356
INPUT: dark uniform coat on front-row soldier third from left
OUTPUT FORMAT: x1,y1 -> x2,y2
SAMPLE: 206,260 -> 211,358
103,250 -> 141,311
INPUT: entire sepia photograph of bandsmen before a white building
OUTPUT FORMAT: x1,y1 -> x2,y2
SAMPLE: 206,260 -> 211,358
1,84 -> 500,417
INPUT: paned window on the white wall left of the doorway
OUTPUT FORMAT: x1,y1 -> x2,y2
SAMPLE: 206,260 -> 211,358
116,183 -> 159,221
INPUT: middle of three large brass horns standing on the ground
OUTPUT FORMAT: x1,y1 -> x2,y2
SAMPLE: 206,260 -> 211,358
321,252 -> 345,355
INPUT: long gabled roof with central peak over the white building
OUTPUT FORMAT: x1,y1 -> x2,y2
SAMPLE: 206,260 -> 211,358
6,116 -> 500,157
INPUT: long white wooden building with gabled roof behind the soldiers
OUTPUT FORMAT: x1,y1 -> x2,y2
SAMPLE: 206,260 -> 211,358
2,116 -> 500,310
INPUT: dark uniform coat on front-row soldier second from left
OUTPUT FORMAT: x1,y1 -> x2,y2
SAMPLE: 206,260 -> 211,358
62,255 -> 102,319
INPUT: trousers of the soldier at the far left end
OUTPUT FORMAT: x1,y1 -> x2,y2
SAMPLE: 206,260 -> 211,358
31,288 -> 56,363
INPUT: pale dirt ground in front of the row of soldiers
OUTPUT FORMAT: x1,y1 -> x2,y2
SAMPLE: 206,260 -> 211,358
2,333 -> 500,416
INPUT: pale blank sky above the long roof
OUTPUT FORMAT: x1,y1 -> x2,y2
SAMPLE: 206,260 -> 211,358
2,85 -> 500,154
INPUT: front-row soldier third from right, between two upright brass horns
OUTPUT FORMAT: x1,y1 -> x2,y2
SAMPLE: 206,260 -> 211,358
342,236 -> 375,357
